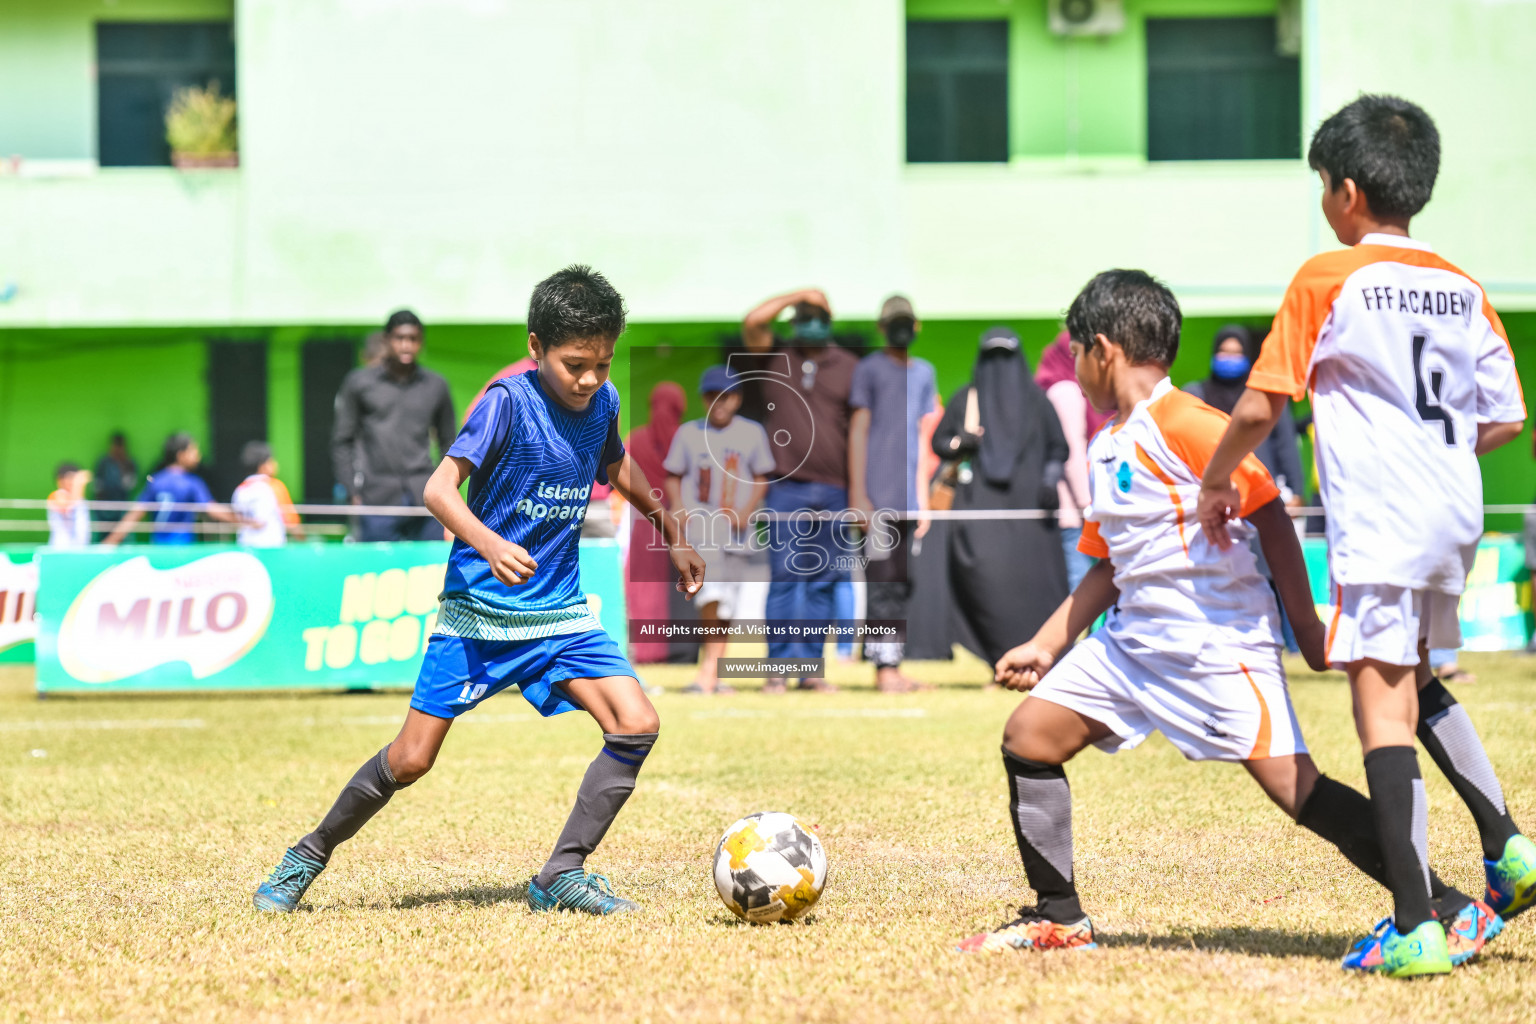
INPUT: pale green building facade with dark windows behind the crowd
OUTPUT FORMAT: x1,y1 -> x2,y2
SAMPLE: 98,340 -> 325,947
0,0 -> 1536,521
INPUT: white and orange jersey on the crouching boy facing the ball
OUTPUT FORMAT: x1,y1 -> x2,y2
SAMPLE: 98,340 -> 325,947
1078,378 -> 1279,652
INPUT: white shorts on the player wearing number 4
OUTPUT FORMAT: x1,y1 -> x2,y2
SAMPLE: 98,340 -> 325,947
1326,583 -> 1461,668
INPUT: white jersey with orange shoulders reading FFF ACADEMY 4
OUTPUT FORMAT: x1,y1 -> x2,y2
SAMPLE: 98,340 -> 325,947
1249,235 -> 1525,594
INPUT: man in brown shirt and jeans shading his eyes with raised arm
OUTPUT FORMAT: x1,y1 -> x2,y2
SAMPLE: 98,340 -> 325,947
742,289 -> 859,692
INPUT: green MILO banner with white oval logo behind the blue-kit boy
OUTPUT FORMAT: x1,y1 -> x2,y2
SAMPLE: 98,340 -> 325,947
37,540 -> 625,692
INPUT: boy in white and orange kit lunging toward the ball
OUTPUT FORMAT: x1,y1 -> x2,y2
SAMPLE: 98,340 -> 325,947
960,270 -> 1498,960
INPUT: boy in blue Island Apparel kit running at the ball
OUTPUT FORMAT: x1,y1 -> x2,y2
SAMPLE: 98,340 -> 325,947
255,266 -> 703,913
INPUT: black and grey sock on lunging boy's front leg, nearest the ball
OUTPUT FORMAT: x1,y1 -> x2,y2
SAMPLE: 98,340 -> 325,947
1003,748 -> 1083,924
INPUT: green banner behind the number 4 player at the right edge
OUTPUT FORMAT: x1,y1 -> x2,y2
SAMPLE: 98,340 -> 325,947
1303,533 -> 1531,651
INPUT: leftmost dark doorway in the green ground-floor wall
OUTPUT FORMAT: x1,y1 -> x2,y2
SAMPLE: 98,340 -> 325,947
203,341 -> 267,502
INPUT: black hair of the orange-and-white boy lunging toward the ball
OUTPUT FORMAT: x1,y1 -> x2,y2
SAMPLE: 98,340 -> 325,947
1066,270 -> 1184,367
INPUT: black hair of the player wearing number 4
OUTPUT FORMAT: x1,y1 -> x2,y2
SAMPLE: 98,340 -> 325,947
1307,94 -> 1439,220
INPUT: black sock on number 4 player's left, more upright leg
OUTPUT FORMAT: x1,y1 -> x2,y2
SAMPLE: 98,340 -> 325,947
1366,746 -> 1430,935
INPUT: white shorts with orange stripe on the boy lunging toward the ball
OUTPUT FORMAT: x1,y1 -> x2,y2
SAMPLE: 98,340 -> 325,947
1032,629 -> 1307,761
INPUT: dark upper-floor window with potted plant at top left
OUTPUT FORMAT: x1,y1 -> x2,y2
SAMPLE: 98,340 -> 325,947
95,21 -> 235,167
